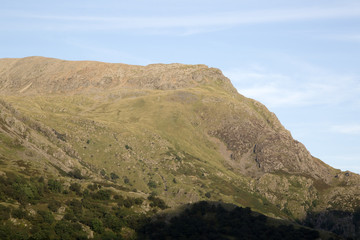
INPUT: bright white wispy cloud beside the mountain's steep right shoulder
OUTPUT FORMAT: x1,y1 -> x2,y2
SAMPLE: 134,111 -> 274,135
224,66 -> 360,107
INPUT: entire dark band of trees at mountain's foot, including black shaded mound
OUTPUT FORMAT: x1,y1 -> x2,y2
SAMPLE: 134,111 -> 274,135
0,173 -> 340,240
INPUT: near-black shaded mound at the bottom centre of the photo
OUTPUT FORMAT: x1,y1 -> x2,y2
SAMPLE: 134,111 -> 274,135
138,201 -> 341,240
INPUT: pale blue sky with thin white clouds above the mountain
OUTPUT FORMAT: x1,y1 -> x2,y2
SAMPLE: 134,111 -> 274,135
0,0 -> 360,173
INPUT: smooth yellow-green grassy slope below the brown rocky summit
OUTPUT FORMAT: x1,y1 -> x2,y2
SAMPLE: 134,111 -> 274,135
2,85 -> 283,216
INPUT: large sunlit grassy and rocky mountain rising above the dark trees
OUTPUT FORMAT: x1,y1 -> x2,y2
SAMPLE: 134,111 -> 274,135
0,57 -> 360,237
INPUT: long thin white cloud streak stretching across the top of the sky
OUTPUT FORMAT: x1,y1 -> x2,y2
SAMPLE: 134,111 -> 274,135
1,5 -> 360,33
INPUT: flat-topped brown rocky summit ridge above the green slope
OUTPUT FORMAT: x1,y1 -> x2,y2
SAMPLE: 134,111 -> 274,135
0,56 -> 236,95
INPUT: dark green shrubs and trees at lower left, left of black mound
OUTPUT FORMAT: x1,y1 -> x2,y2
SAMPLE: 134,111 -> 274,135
0,172 -> 162,240
